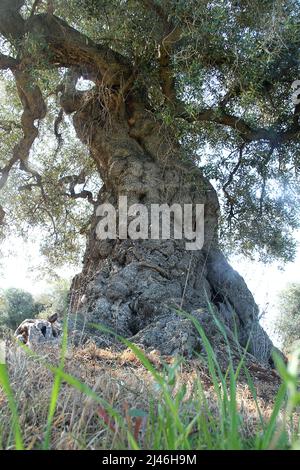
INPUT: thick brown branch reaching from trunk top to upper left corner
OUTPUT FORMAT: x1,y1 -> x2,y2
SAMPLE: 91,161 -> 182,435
0,0 -> 131,85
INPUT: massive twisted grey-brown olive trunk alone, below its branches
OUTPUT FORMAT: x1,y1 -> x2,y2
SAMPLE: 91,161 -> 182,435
63,91 -> 271,368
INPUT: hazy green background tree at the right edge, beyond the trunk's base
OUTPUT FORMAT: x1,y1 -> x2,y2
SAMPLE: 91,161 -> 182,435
277,283 -> 300,352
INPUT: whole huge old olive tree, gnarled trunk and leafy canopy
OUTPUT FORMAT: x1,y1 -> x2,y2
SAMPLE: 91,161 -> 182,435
0,0 -> 300,361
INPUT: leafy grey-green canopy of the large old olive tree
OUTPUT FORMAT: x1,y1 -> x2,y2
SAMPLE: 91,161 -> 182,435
0,0 -> 300,263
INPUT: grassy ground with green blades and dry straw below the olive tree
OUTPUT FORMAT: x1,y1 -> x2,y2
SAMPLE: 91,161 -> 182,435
0,318 -> 300,450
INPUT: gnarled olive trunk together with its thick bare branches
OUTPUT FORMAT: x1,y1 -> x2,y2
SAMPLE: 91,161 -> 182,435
0,0 -> 278,362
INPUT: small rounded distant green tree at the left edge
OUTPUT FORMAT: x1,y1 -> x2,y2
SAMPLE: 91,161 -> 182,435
0,288 -> 43,330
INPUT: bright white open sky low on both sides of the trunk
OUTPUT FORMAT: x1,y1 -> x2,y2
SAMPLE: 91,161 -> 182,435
0,232 -> 300,344
